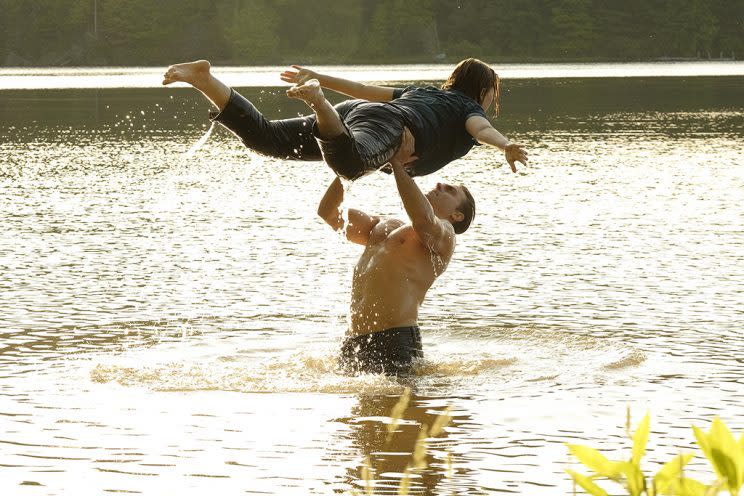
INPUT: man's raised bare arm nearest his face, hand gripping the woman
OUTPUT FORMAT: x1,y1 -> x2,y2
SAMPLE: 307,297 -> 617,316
390,128 -> 455,255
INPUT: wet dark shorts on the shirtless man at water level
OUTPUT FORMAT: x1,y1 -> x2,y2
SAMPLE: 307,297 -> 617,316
340,326 -> 424,375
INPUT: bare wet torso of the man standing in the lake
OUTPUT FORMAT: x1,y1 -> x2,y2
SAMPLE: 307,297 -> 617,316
349,219 -> 451,335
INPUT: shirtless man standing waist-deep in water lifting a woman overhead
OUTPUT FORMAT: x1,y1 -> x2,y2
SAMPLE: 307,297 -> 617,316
318,129 -> 475,375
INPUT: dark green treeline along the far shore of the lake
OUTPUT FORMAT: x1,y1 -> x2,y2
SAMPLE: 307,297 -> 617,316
0,0 -> 744,66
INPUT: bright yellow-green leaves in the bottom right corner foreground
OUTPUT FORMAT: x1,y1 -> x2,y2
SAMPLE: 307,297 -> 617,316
566,413 -> 744,496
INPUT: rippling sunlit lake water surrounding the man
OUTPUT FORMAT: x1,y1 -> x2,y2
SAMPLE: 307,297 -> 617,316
0,63 -> 744,495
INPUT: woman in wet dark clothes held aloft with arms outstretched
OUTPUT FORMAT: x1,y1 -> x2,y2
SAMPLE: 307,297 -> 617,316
163,59 -> 527,179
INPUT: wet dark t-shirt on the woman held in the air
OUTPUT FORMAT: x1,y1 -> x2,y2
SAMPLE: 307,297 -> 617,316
389,86 -> 486,176
